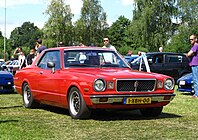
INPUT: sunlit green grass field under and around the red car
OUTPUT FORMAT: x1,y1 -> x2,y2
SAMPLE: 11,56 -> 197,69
0,89 -> 198,140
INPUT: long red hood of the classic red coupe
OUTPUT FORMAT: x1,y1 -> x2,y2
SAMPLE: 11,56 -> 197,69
66,68 -> 169,79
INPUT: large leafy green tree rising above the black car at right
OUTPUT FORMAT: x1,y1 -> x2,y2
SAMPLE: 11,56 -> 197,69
125,0 -> 179,51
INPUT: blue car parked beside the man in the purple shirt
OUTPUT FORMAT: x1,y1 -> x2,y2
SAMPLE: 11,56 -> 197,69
177,73 -> 194,93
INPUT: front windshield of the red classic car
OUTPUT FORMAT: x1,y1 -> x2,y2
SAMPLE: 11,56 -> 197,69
64,50 -> 129,68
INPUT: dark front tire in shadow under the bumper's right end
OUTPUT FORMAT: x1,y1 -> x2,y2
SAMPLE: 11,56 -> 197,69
140,107 -> 163,117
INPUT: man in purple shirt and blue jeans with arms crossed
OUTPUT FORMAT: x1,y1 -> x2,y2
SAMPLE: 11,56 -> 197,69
186,35 -> 198,98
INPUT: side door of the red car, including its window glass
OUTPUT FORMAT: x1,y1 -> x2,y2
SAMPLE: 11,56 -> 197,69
38,50 -> 61,102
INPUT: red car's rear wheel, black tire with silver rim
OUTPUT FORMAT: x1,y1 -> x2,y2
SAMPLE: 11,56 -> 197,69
23,83 -> 38,108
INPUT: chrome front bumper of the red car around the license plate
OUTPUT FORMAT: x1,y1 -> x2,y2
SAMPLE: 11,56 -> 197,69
90,94 -> 175,104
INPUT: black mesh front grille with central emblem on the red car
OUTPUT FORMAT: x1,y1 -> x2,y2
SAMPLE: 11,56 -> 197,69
117,79 -> 156,92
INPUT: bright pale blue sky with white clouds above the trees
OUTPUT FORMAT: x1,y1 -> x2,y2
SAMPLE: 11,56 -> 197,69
0,0 -> 134,38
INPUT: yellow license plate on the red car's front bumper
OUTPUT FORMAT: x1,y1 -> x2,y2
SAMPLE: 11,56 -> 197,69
124,97 -> 151,104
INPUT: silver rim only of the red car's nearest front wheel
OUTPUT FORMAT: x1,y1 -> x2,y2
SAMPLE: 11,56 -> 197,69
69,91 -> 80,115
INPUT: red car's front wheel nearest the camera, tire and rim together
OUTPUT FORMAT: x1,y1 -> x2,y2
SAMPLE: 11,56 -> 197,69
68,87 -> 91,119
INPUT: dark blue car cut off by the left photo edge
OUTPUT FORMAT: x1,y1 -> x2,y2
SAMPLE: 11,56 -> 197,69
0,71 -> 14,94
